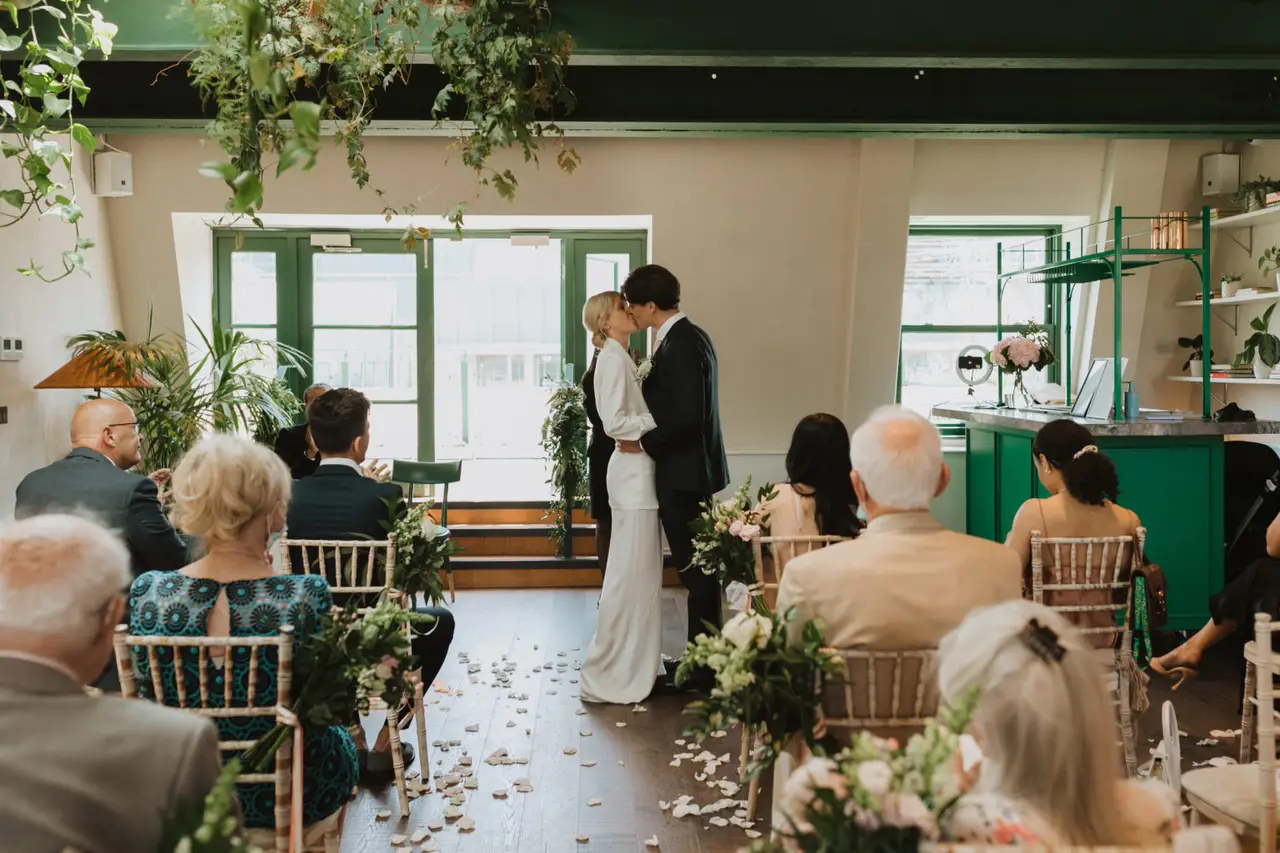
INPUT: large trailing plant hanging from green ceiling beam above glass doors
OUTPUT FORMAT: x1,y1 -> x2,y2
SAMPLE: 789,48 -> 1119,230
189,0 -> 424,225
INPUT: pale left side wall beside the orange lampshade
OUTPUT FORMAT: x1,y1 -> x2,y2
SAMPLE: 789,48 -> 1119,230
0,142 -> 119,519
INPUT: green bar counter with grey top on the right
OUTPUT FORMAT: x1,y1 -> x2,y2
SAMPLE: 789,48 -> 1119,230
933,406 -> 1280,630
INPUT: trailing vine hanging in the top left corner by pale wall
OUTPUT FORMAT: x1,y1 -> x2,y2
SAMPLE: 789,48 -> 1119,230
0,0 -> 116,282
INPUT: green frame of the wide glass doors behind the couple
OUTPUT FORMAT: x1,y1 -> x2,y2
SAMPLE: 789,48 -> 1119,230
212,228 -> 649,461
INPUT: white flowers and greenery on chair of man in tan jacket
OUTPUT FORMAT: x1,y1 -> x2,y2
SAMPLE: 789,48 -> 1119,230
676,608 -> 840,775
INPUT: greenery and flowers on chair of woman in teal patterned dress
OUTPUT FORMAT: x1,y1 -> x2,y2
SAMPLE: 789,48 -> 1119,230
242,594 -> 435,771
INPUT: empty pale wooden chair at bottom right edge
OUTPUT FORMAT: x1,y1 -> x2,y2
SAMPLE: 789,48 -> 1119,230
1183,613 -> 1280,853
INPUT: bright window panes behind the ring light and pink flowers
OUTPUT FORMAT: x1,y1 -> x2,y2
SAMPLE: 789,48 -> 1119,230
897,227 -> 1057,416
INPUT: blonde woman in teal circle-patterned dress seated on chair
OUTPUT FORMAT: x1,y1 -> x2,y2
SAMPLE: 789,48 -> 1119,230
129,435 -> 358,827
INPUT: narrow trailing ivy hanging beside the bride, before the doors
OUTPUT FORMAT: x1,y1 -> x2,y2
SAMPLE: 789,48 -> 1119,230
541,382 -> 588,557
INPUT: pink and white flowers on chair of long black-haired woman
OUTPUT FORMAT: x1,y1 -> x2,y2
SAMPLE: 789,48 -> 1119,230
685,476 -> 776,604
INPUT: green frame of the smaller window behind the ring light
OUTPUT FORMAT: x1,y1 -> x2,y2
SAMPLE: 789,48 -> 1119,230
895,224 -> 1064,437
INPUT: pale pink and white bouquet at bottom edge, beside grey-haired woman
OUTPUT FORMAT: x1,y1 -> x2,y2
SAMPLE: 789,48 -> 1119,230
750,689 -> 978,853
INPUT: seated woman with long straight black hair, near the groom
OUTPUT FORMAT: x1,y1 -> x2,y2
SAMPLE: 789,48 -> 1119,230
760,414 -> 863,573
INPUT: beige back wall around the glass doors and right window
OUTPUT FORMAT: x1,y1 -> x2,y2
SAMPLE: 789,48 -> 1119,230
0,134 -> 1239,517
